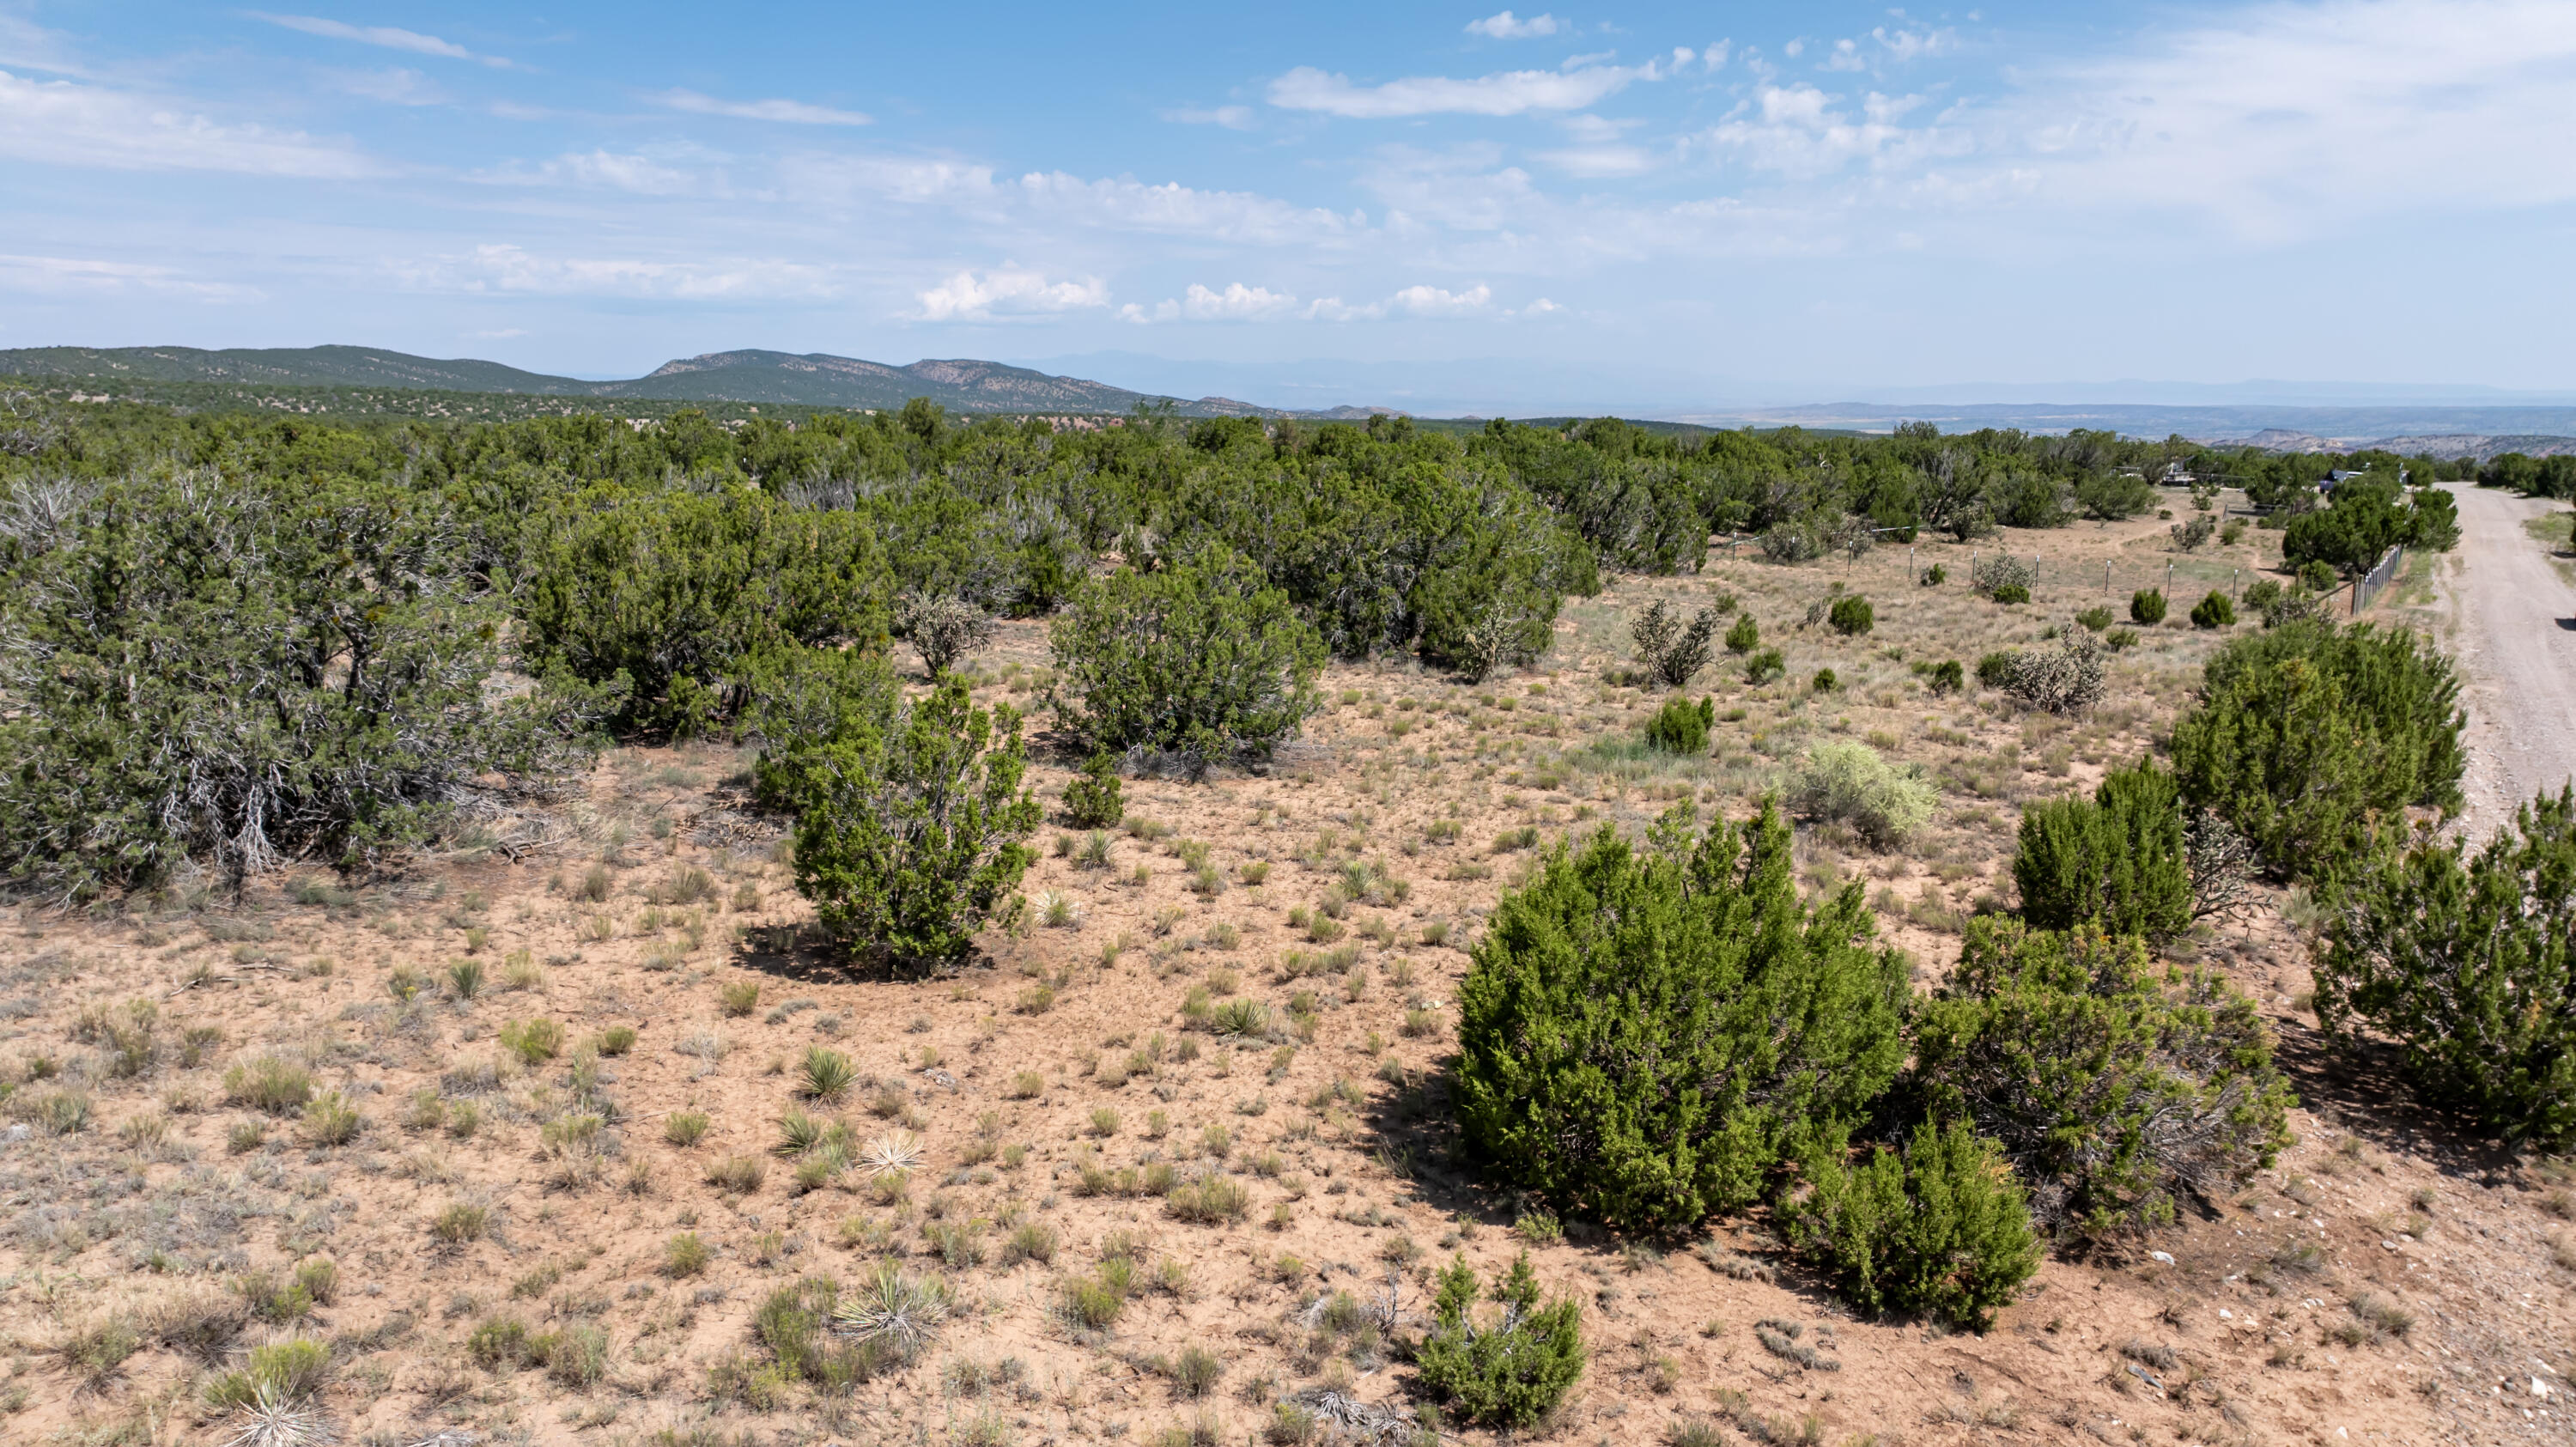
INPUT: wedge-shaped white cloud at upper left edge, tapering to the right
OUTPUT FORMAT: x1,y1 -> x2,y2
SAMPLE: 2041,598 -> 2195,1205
0,70 -> 376,180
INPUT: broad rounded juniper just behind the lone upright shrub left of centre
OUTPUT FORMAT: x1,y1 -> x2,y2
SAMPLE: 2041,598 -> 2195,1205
520,484 -> 894,731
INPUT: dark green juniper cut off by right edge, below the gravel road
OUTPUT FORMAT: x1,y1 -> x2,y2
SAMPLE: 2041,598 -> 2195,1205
2316,787 -> 2576,1148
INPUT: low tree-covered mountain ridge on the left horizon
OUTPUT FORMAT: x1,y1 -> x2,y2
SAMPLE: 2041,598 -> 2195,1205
0,345 -> 1283,417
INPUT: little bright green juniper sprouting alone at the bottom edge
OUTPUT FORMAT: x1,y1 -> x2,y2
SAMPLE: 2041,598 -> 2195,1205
1414,1251 -> 1584,1426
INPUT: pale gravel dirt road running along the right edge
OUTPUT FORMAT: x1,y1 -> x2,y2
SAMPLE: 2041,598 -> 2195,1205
2439,487 -> 2576,842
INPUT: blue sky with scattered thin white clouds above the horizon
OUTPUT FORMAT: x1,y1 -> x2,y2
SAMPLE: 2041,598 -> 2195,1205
0,0 -> 2576,399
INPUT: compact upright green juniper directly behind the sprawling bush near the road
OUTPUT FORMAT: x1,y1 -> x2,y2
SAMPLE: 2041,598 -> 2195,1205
2012,759 -> 2192,939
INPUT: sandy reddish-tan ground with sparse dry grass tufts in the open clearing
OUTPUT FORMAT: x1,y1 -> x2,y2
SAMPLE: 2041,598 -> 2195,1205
0,499 -> 2576,1447
